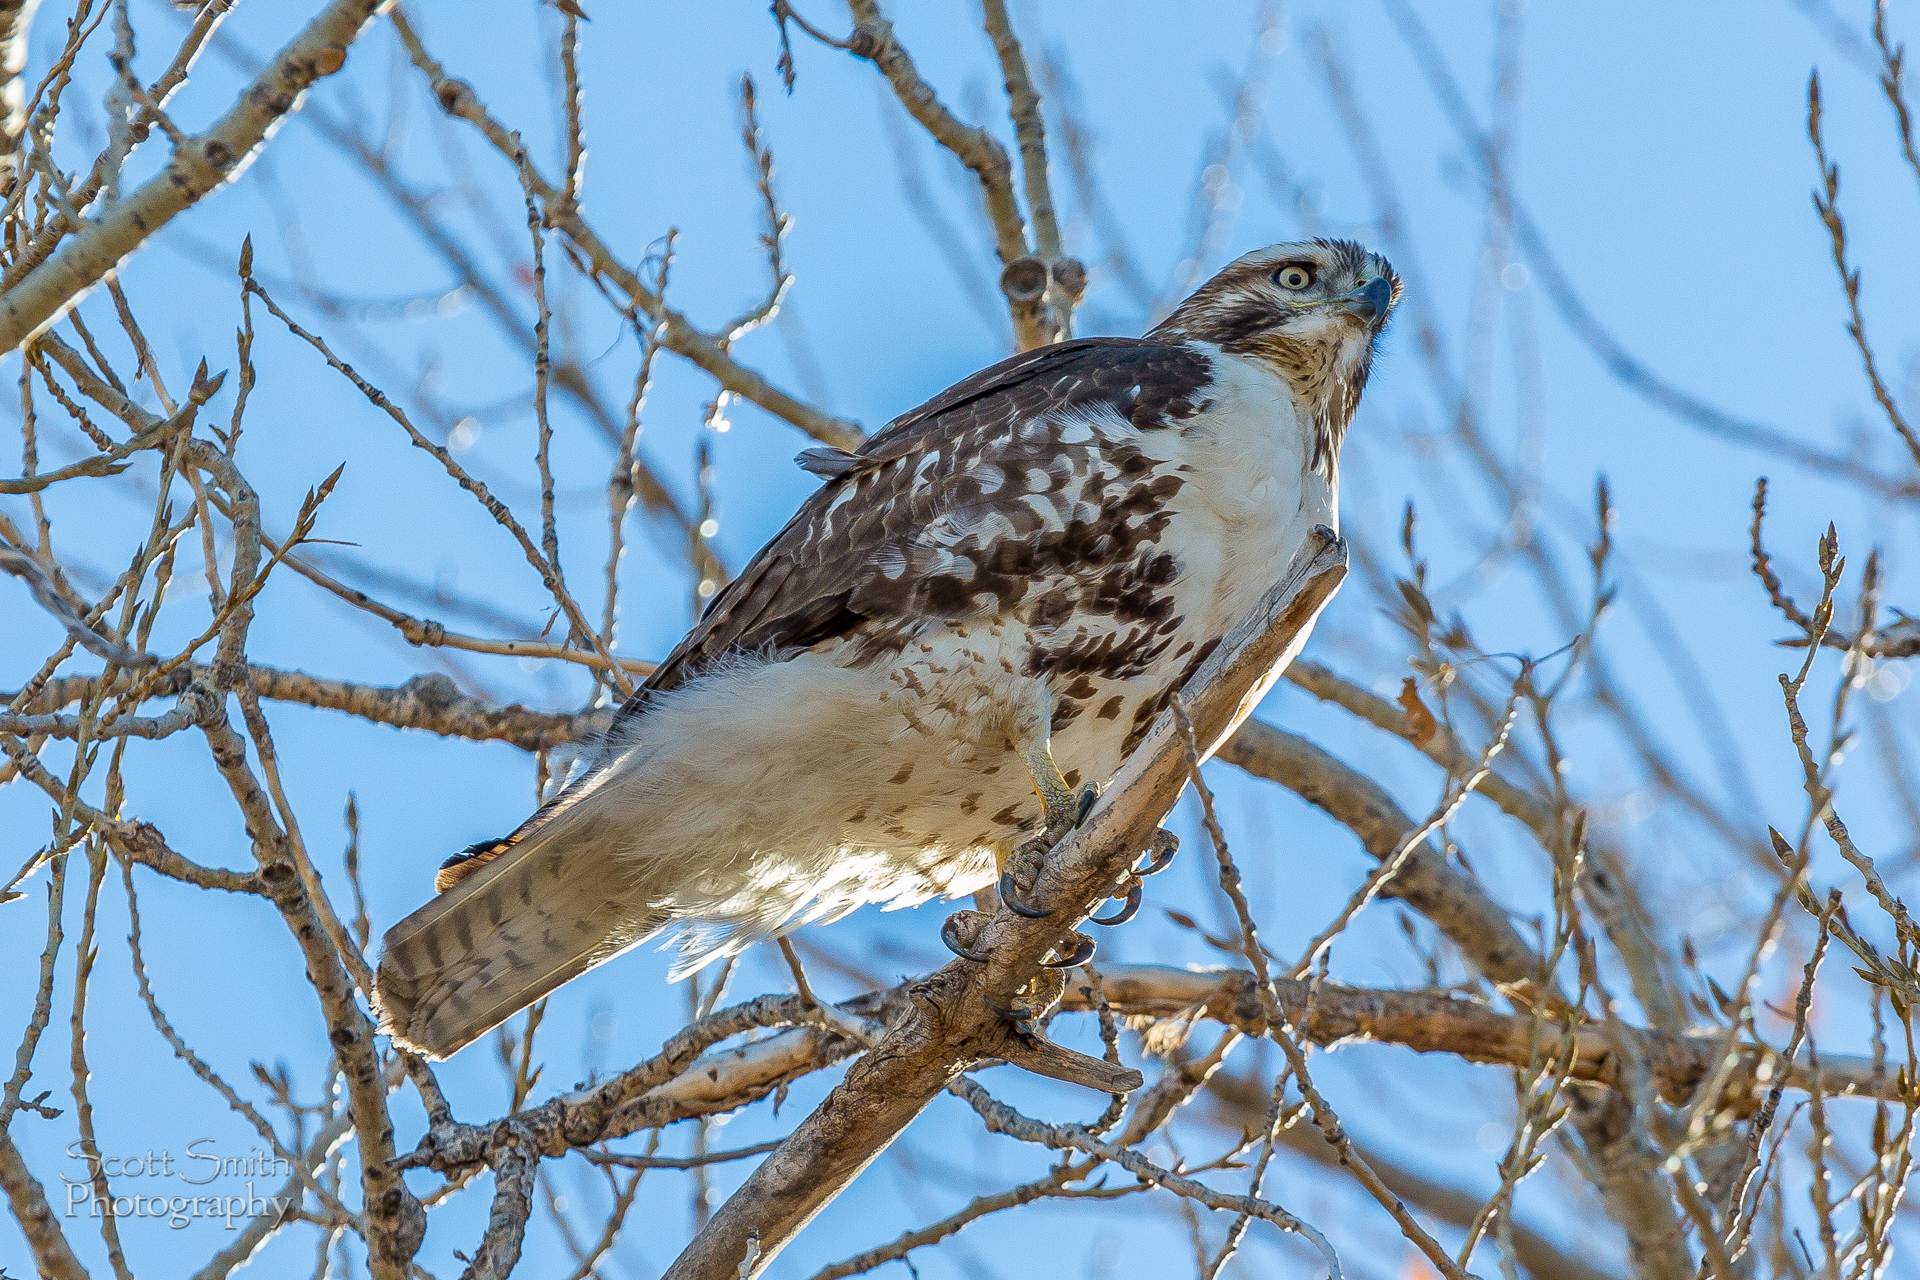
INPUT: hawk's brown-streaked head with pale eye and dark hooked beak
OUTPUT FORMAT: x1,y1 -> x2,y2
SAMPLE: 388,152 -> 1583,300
1150,240 -> 1400,458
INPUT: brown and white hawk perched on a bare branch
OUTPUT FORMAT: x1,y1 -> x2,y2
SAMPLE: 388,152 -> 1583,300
376,240 -> 1400,1057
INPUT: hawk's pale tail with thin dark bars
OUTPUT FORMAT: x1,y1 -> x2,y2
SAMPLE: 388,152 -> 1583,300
374,816 -> 664,1057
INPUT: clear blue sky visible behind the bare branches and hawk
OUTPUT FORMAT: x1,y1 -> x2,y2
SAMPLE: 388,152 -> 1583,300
0,0 -> 1920,1278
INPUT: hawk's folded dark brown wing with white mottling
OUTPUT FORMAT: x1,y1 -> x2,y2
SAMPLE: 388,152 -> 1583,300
438,338 -> 1213,889
